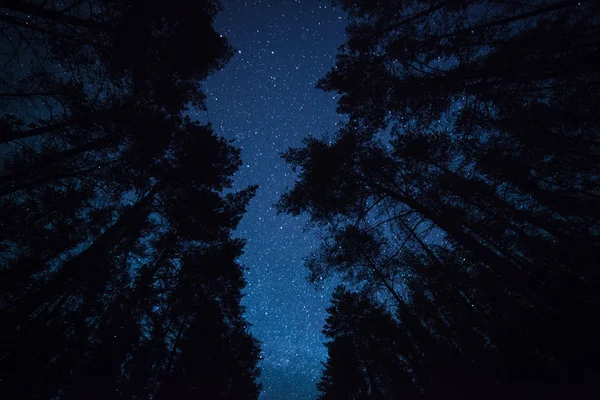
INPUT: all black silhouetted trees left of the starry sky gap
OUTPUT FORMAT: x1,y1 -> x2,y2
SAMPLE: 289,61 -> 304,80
0,0 -> 260,399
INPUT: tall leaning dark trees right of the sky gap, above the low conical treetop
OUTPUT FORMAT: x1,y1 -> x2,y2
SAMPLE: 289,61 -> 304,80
279,0 -> 600,398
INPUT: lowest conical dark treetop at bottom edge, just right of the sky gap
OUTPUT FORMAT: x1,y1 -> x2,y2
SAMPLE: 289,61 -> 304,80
318,286 -> 417,400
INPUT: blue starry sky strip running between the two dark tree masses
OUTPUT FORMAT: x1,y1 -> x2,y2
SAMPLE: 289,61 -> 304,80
192,0 -> 347,400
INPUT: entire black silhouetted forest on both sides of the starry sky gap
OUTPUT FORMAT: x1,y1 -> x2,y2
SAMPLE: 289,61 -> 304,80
0,0 -> 600,400
